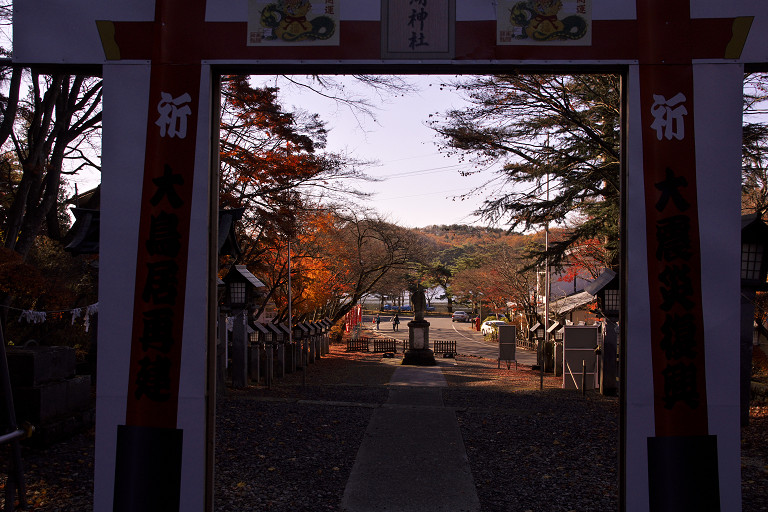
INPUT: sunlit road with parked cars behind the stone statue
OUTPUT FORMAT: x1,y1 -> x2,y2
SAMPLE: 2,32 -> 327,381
363,315 -> 536,365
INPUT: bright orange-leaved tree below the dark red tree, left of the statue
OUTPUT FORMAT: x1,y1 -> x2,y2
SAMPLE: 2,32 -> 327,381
236,208 -> 418,321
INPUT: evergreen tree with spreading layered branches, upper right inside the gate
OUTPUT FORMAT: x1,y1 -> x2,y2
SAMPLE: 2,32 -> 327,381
432,74 -> 620,266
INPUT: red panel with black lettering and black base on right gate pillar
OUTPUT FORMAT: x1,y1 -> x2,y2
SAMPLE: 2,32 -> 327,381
627,1 -> 742,512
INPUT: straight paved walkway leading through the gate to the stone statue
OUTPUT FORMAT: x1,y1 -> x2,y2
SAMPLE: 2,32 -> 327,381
342,362 -> 480,512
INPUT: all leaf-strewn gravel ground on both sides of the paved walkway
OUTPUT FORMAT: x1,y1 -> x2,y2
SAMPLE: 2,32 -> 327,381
0,346 -> 768,512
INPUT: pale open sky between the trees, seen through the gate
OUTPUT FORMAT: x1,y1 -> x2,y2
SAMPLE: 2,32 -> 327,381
260,76 -> 508,227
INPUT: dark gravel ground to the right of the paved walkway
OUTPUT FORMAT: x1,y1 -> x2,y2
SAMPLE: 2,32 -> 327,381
445,360 -> 618,512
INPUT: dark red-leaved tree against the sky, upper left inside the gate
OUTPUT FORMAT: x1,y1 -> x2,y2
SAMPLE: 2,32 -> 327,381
219,75 -> 368,232
